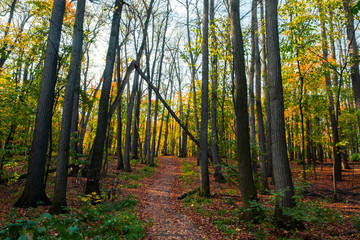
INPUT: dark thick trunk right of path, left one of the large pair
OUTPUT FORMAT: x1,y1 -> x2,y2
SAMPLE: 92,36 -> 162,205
230,0 -> 257,220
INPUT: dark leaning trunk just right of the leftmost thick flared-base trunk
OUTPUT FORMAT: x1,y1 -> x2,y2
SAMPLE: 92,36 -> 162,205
50,0 -> 86,214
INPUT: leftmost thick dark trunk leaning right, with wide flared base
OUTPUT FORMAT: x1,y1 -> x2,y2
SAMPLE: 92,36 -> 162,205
15,0 -> 65,207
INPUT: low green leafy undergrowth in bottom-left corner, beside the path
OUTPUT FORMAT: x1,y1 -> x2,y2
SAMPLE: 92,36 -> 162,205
0,196 -> 145,240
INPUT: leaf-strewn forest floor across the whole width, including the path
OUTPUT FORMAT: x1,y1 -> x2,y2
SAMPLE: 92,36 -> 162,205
0,156 -> 360,239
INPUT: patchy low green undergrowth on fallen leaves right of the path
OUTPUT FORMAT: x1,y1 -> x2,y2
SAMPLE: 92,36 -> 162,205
179,160 -> 348,239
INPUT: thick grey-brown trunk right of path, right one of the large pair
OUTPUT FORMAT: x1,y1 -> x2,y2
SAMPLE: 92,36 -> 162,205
266,0 -> 295,215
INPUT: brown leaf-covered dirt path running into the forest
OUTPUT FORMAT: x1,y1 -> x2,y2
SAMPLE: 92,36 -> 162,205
142,156 -> 207,240
